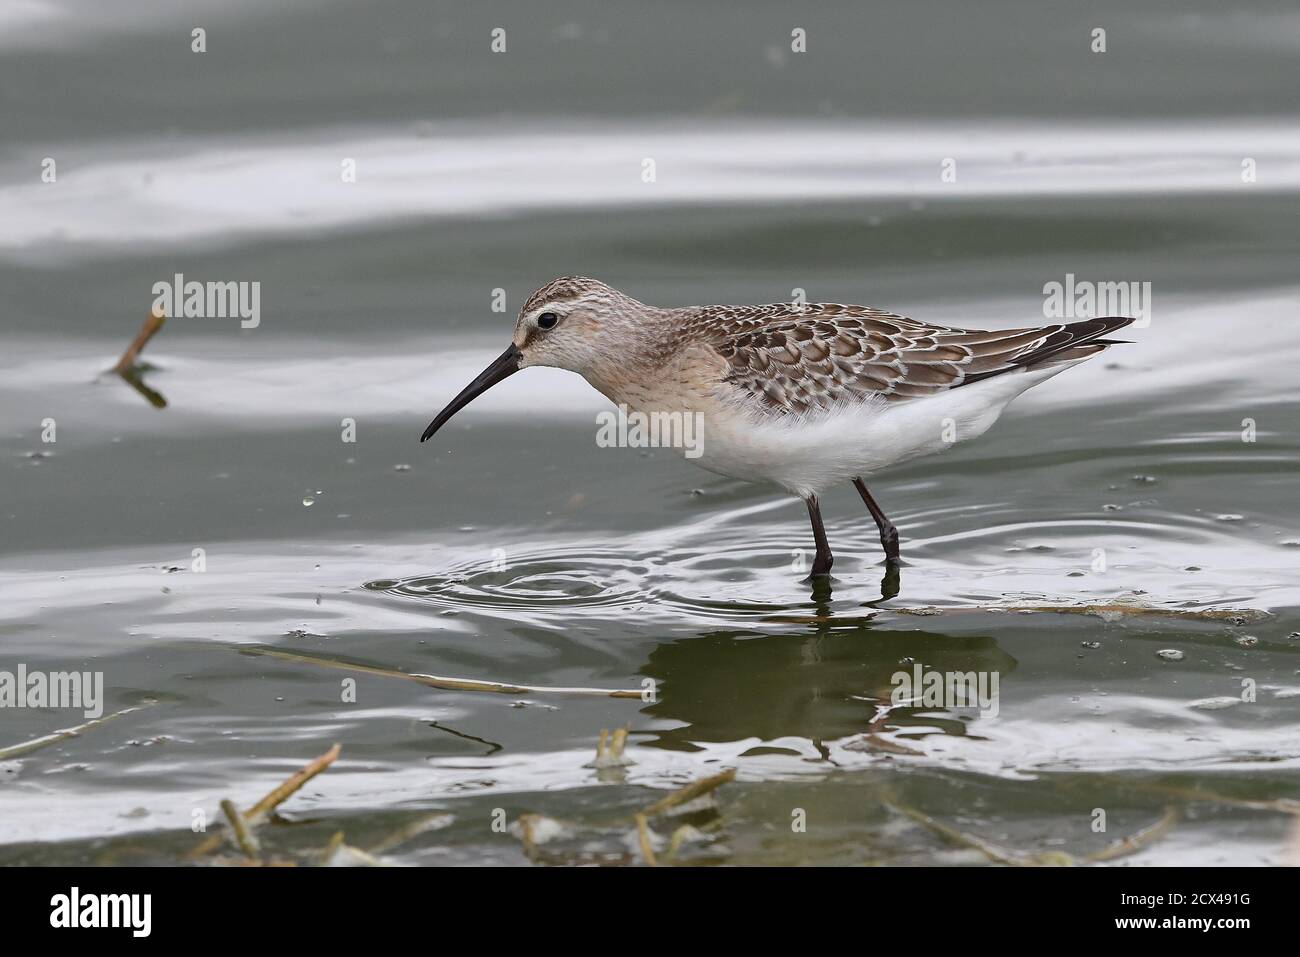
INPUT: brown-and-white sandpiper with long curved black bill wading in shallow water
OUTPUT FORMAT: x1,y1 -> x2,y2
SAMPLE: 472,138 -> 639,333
420,276 -> 1134,579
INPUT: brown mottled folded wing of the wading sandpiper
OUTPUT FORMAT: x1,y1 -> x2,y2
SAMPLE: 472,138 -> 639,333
697,303 -> 1132,413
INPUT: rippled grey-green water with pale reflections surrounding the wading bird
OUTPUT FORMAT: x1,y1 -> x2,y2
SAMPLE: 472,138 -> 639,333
0,3 -> 1300,865
